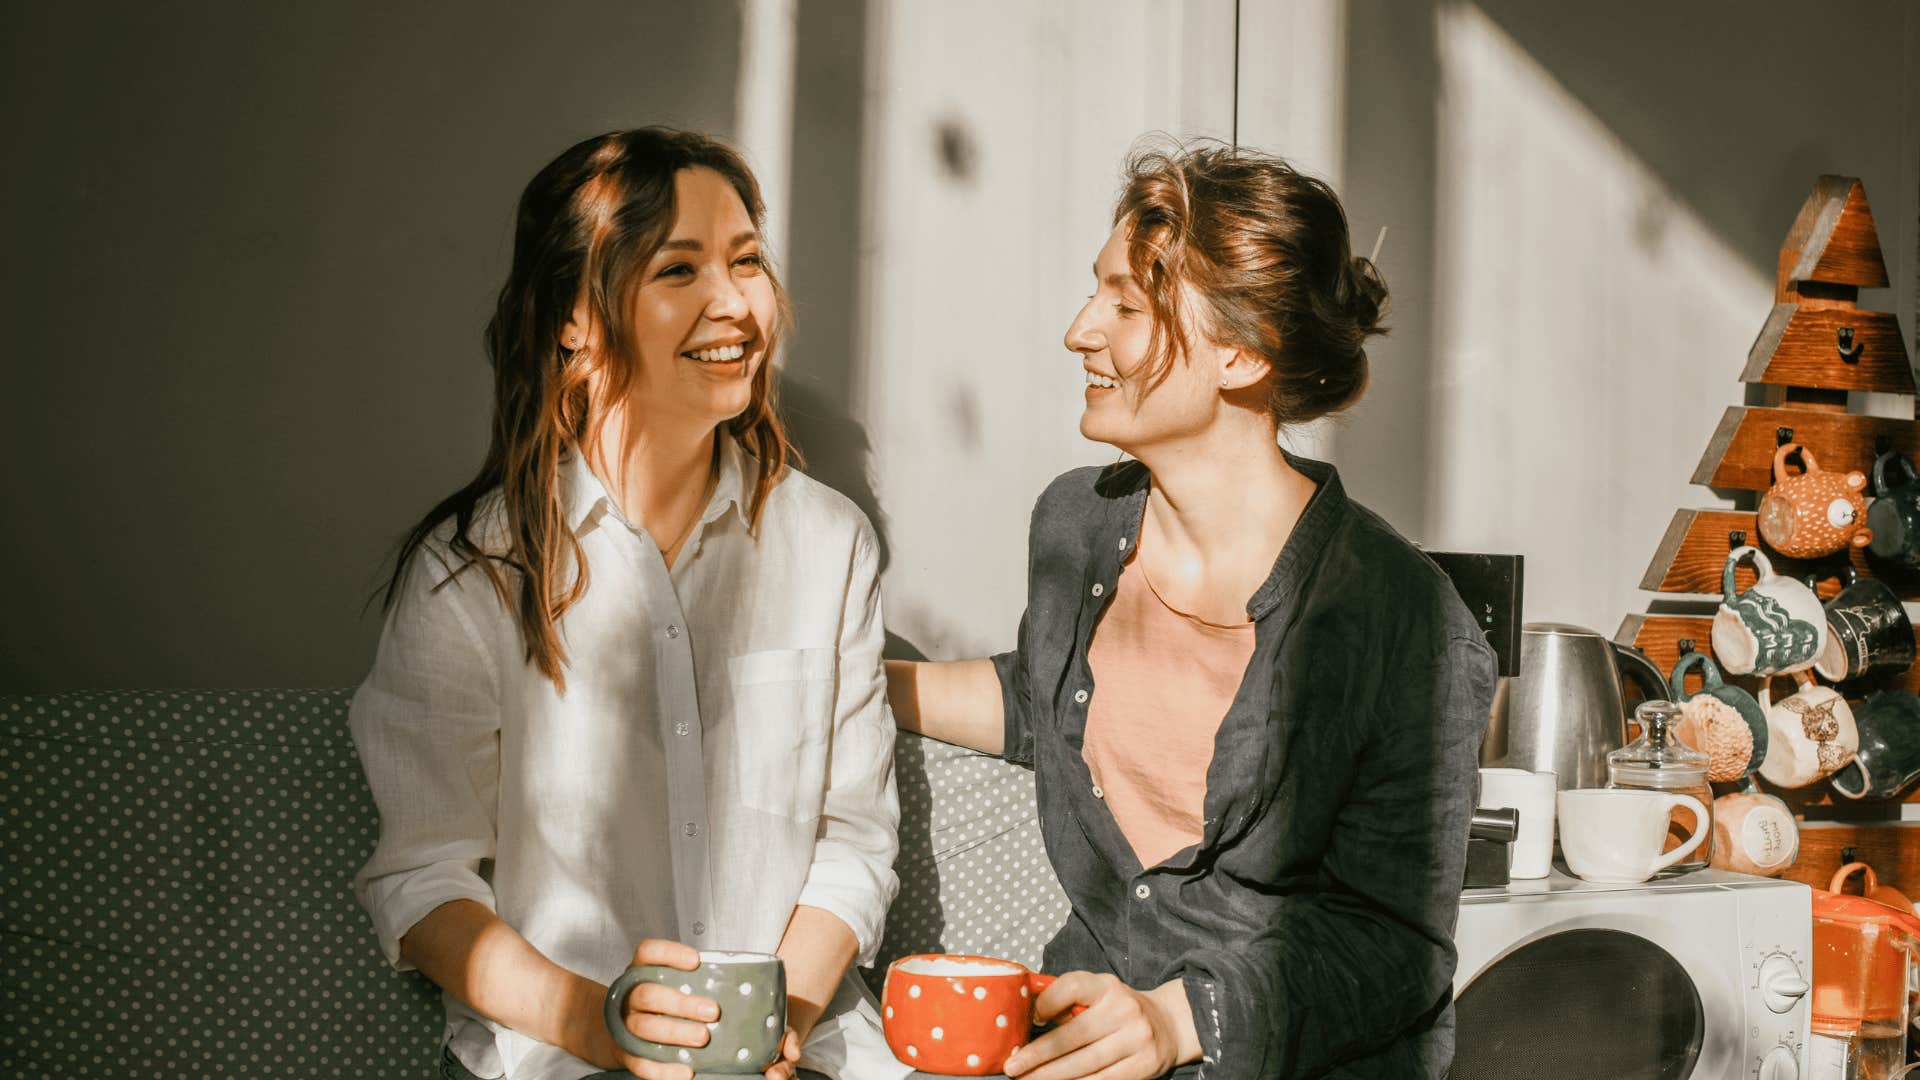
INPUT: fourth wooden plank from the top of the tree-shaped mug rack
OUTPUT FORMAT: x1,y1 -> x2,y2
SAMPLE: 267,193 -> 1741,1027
1640,507 -> 1920,601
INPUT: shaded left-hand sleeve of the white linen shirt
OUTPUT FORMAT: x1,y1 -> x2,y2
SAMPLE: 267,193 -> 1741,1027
348,548 -> 499,970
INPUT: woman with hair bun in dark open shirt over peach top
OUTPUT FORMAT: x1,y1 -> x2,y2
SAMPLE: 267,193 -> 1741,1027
887,144 -> 1494,1080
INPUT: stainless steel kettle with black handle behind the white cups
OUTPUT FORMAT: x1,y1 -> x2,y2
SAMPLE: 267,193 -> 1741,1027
1480,623 -> 1667,790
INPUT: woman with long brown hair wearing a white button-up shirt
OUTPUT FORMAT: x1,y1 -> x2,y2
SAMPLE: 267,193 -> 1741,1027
351,129 -> 904,1080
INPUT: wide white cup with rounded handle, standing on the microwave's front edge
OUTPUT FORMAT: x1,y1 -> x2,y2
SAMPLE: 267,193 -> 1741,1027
1559,788 -> 1711,884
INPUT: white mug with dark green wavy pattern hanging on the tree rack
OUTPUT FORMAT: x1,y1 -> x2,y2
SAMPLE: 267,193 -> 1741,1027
1713,544 -> 1826,675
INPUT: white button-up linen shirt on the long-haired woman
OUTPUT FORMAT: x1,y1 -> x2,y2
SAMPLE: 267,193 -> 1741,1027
349,432 -> 910,1080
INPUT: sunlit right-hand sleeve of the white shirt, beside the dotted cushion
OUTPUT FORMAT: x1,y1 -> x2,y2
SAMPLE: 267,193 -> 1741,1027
799,521 -> 900,967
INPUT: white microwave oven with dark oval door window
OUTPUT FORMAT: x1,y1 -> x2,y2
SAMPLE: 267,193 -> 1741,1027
1450,867 -> 1812,1080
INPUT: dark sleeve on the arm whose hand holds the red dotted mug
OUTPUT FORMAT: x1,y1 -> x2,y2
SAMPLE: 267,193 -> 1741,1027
1183,638 -> 1494,1078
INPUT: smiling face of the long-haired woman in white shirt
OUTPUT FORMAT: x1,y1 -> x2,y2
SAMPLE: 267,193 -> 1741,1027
599,167 -> 778,429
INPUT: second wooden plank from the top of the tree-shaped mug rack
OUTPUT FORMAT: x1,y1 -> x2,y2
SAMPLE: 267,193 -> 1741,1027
1740,304 -> 1914,393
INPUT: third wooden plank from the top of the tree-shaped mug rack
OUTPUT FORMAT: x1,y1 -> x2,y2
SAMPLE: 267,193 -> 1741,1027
1693,405 -> 1920,492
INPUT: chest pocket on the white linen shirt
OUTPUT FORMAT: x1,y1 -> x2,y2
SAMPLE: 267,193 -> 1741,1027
726,650 -> 835,821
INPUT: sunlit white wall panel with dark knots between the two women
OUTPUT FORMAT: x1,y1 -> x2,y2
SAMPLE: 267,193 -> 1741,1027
854,0 -> 1235,659
